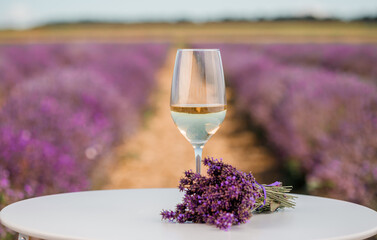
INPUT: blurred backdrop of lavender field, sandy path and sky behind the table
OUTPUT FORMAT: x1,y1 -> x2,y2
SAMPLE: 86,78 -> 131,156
0,0 -> 377,239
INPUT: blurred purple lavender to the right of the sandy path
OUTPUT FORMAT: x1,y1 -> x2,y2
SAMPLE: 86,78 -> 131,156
194,44 -> 377,208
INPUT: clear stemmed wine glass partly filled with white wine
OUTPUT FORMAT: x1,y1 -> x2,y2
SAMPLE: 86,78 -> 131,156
170,49 -> 226,174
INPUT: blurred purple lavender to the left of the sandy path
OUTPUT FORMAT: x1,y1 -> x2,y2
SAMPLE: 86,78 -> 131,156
0,44 -> 168,236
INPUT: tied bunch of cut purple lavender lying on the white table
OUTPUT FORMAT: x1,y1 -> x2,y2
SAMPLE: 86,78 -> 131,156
161,158 -> 295,230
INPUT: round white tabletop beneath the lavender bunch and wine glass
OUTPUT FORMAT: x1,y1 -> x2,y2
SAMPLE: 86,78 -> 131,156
0,189 -> 377,240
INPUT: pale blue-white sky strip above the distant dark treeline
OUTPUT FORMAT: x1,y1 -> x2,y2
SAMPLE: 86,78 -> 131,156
0,0 -> 377,29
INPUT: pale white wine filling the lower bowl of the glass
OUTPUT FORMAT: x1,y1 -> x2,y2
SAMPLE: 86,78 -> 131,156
170,104 -> 226,145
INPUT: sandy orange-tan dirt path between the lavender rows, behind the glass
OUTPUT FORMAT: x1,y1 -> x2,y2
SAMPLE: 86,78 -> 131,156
104,48 -> 277,189
